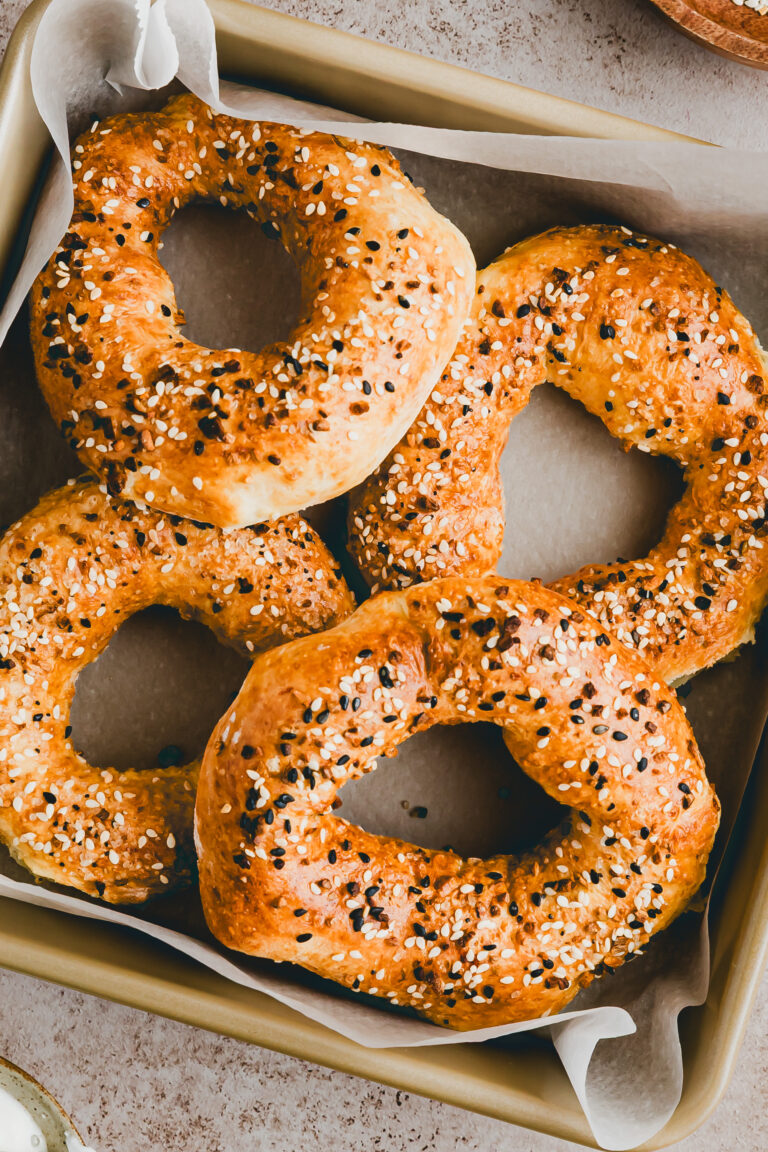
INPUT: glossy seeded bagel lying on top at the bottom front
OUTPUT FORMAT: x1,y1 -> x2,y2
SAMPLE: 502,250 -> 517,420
196,576 -> 718,1029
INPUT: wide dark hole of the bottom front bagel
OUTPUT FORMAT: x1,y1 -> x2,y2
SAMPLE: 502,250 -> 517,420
336,723 -> 567,856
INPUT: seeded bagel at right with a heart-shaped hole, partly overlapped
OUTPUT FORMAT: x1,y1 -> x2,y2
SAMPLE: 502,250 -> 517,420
349,225 -> 768,681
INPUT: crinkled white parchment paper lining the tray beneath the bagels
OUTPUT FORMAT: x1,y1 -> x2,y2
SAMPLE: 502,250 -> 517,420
0,0 -> 768,1150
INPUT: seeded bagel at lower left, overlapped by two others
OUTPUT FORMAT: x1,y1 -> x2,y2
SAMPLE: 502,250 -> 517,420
0,479 -> 352,903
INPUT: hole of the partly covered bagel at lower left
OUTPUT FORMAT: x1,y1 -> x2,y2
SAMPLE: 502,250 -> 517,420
70,607 -> 249,771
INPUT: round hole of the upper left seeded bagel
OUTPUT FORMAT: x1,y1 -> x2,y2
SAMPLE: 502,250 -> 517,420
160,204 -> 301,351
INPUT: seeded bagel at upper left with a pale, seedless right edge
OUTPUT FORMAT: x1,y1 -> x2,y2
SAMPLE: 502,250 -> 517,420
31,94 -> 474,528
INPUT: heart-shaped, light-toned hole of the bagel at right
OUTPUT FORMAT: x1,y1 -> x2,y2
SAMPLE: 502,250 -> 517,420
499,384 -> 684,581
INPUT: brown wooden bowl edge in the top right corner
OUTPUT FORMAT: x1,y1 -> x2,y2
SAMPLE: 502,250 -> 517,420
651,0 -> 768,68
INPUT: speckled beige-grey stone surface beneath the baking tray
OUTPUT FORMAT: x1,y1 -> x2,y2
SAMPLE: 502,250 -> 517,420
0,0 -> 768,1152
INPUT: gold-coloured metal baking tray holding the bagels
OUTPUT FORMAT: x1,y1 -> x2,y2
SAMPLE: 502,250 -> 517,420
0,0 -> 768,1150
